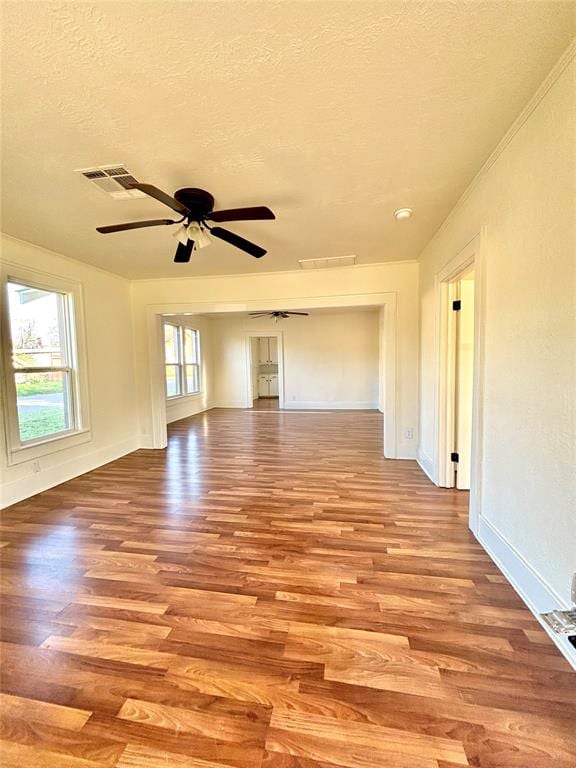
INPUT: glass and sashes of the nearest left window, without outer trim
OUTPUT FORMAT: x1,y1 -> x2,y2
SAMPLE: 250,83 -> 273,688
8,282 -> 74,443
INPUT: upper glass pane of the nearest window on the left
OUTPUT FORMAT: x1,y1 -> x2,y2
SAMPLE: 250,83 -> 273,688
8,283 -> 66,368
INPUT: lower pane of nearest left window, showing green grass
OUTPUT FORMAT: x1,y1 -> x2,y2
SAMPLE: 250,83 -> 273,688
15,371 -> 71,442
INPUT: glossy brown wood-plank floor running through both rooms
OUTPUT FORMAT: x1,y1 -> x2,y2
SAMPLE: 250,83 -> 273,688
0,411 -> 576,768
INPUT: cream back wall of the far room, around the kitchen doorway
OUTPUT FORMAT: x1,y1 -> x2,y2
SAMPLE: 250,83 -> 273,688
210,310 -> 379,408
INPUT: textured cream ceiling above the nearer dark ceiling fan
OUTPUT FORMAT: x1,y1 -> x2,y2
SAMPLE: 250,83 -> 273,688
1,0 -> 576,278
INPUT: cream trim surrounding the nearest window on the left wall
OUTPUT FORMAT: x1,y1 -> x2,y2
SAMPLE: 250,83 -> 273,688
1,263 -> 92,466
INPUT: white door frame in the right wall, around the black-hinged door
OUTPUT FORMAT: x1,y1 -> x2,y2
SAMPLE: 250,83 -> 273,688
434,230 -> 485,533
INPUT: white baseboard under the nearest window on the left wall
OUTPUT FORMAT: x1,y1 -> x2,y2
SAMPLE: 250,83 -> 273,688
0,437 -> 140,509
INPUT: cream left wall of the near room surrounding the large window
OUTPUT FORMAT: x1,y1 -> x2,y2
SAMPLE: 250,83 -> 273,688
0,236 -> 139,506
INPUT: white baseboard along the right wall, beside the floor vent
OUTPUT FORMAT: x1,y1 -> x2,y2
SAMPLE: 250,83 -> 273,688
477,517 -> 576,669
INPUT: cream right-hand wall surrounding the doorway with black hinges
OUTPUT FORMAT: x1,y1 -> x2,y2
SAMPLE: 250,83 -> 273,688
420,52 -> 576,607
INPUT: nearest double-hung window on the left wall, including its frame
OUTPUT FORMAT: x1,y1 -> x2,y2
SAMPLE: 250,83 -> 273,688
5,278 -> 86,463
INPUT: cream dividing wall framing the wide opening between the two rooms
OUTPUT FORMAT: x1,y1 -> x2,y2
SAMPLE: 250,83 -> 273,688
133,256 -> 418,458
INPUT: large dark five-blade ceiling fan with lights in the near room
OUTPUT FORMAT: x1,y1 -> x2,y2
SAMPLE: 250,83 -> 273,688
96,182 -> 276,263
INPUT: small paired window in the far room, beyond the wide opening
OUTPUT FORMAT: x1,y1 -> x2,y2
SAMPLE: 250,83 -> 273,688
164,323 -> 200,398
